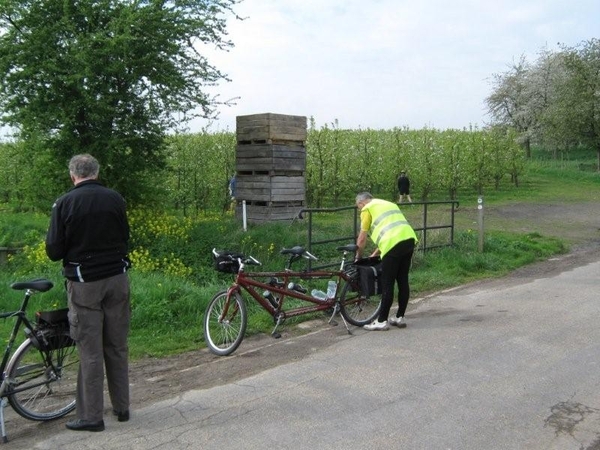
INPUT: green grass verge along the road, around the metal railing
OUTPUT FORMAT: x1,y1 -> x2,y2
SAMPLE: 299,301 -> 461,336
0,155 -> 600,359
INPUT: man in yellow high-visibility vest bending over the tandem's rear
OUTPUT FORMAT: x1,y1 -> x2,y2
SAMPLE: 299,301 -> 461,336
356,192 -> 417,331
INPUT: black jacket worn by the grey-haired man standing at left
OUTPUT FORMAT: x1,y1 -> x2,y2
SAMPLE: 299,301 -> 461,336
46,180 -> 129,282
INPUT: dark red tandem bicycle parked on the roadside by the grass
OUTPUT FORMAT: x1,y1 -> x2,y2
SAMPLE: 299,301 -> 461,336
204,244 -> 381,356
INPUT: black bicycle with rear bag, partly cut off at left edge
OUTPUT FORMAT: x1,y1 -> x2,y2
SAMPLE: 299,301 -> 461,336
0,279 -> 79,442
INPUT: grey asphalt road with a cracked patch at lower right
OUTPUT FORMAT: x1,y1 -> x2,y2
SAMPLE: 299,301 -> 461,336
21,251 -> 600,450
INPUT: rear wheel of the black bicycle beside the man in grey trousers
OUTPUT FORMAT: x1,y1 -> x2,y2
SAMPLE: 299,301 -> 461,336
6,330 -> 79,421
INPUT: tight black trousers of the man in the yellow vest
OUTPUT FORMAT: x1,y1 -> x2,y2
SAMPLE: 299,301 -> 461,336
378,239 -> 415,322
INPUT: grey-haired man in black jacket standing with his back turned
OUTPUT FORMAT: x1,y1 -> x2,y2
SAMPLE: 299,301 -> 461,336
46,155 -> 131,431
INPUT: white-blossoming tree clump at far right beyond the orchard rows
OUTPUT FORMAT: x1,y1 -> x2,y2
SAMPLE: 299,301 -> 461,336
486,38 -> 600,165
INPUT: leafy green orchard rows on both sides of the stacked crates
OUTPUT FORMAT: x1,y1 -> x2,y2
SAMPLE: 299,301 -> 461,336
0,122 -> 536,217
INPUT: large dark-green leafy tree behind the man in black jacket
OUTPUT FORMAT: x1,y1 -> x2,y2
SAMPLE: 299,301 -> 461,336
0,0 -> 238,201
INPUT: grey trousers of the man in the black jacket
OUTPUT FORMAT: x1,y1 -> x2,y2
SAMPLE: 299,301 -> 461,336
67,273 -> 131,421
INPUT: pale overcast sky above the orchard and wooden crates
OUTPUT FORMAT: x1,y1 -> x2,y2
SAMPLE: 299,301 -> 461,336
190,0 -> 600,132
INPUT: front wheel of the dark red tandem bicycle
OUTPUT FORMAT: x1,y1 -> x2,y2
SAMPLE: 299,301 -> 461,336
204,291 -> 248,356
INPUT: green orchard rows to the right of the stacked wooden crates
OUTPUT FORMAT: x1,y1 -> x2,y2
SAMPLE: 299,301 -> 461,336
306,122 -> 524,208
